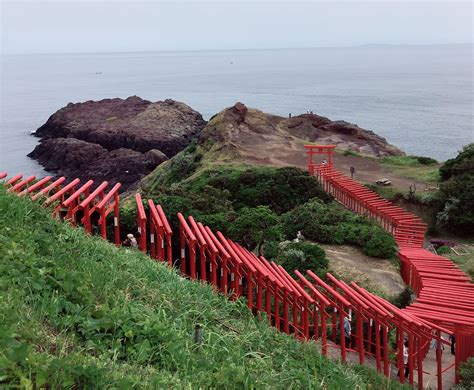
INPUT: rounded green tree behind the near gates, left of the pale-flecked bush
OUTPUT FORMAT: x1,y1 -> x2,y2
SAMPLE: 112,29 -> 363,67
230,206 -> 281,256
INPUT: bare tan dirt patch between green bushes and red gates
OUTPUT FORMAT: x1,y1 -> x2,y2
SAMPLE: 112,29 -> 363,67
321,245 -> 405,296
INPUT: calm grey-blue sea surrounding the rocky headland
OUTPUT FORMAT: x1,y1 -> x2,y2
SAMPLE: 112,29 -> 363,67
0,45 -> 474,175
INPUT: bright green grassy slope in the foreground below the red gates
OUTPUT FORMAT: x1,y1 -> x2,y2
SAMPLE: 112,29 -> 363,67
0,187 -> 408,389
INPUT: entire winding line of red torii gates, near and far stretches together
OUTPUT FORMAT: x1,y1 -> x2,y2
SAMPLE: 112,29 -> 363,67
0,163 -> 474,389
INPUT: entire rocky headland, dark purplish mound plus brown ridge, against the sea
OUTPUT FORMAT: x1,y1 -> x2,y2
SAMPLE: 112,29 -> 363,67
29,96 -> 404,190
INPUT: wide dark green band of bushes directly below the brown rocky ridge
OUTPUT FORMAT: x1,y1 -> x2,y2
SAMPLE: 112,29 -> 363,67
144,163 -> 331,214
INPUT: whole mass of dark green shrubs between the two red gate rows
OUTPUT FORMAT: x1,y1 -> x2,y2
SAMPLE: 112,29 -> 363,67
134,141 -> 395,276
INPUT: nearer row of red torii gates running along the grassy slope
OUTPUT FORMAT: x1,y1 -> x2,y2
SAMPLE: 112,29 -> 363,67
0,147 -> 474,389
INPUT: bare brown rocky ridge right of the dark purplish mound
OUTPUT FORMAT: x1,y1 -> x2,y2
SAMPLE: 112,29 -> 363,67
200,103 -> 404,166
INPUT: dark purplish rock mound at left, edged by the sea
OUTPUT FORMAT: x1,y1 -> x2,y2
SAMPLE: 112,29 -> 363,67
29,96 -> 206,190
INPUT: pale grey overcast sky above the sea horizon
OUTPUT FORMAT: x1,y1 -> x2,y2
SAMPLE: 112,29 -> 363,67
0,0 -> 473,54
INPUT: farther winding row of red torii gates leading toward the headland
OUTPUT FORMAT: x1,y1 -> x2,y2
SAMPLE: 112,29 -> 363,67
305,145 -> 474,387
